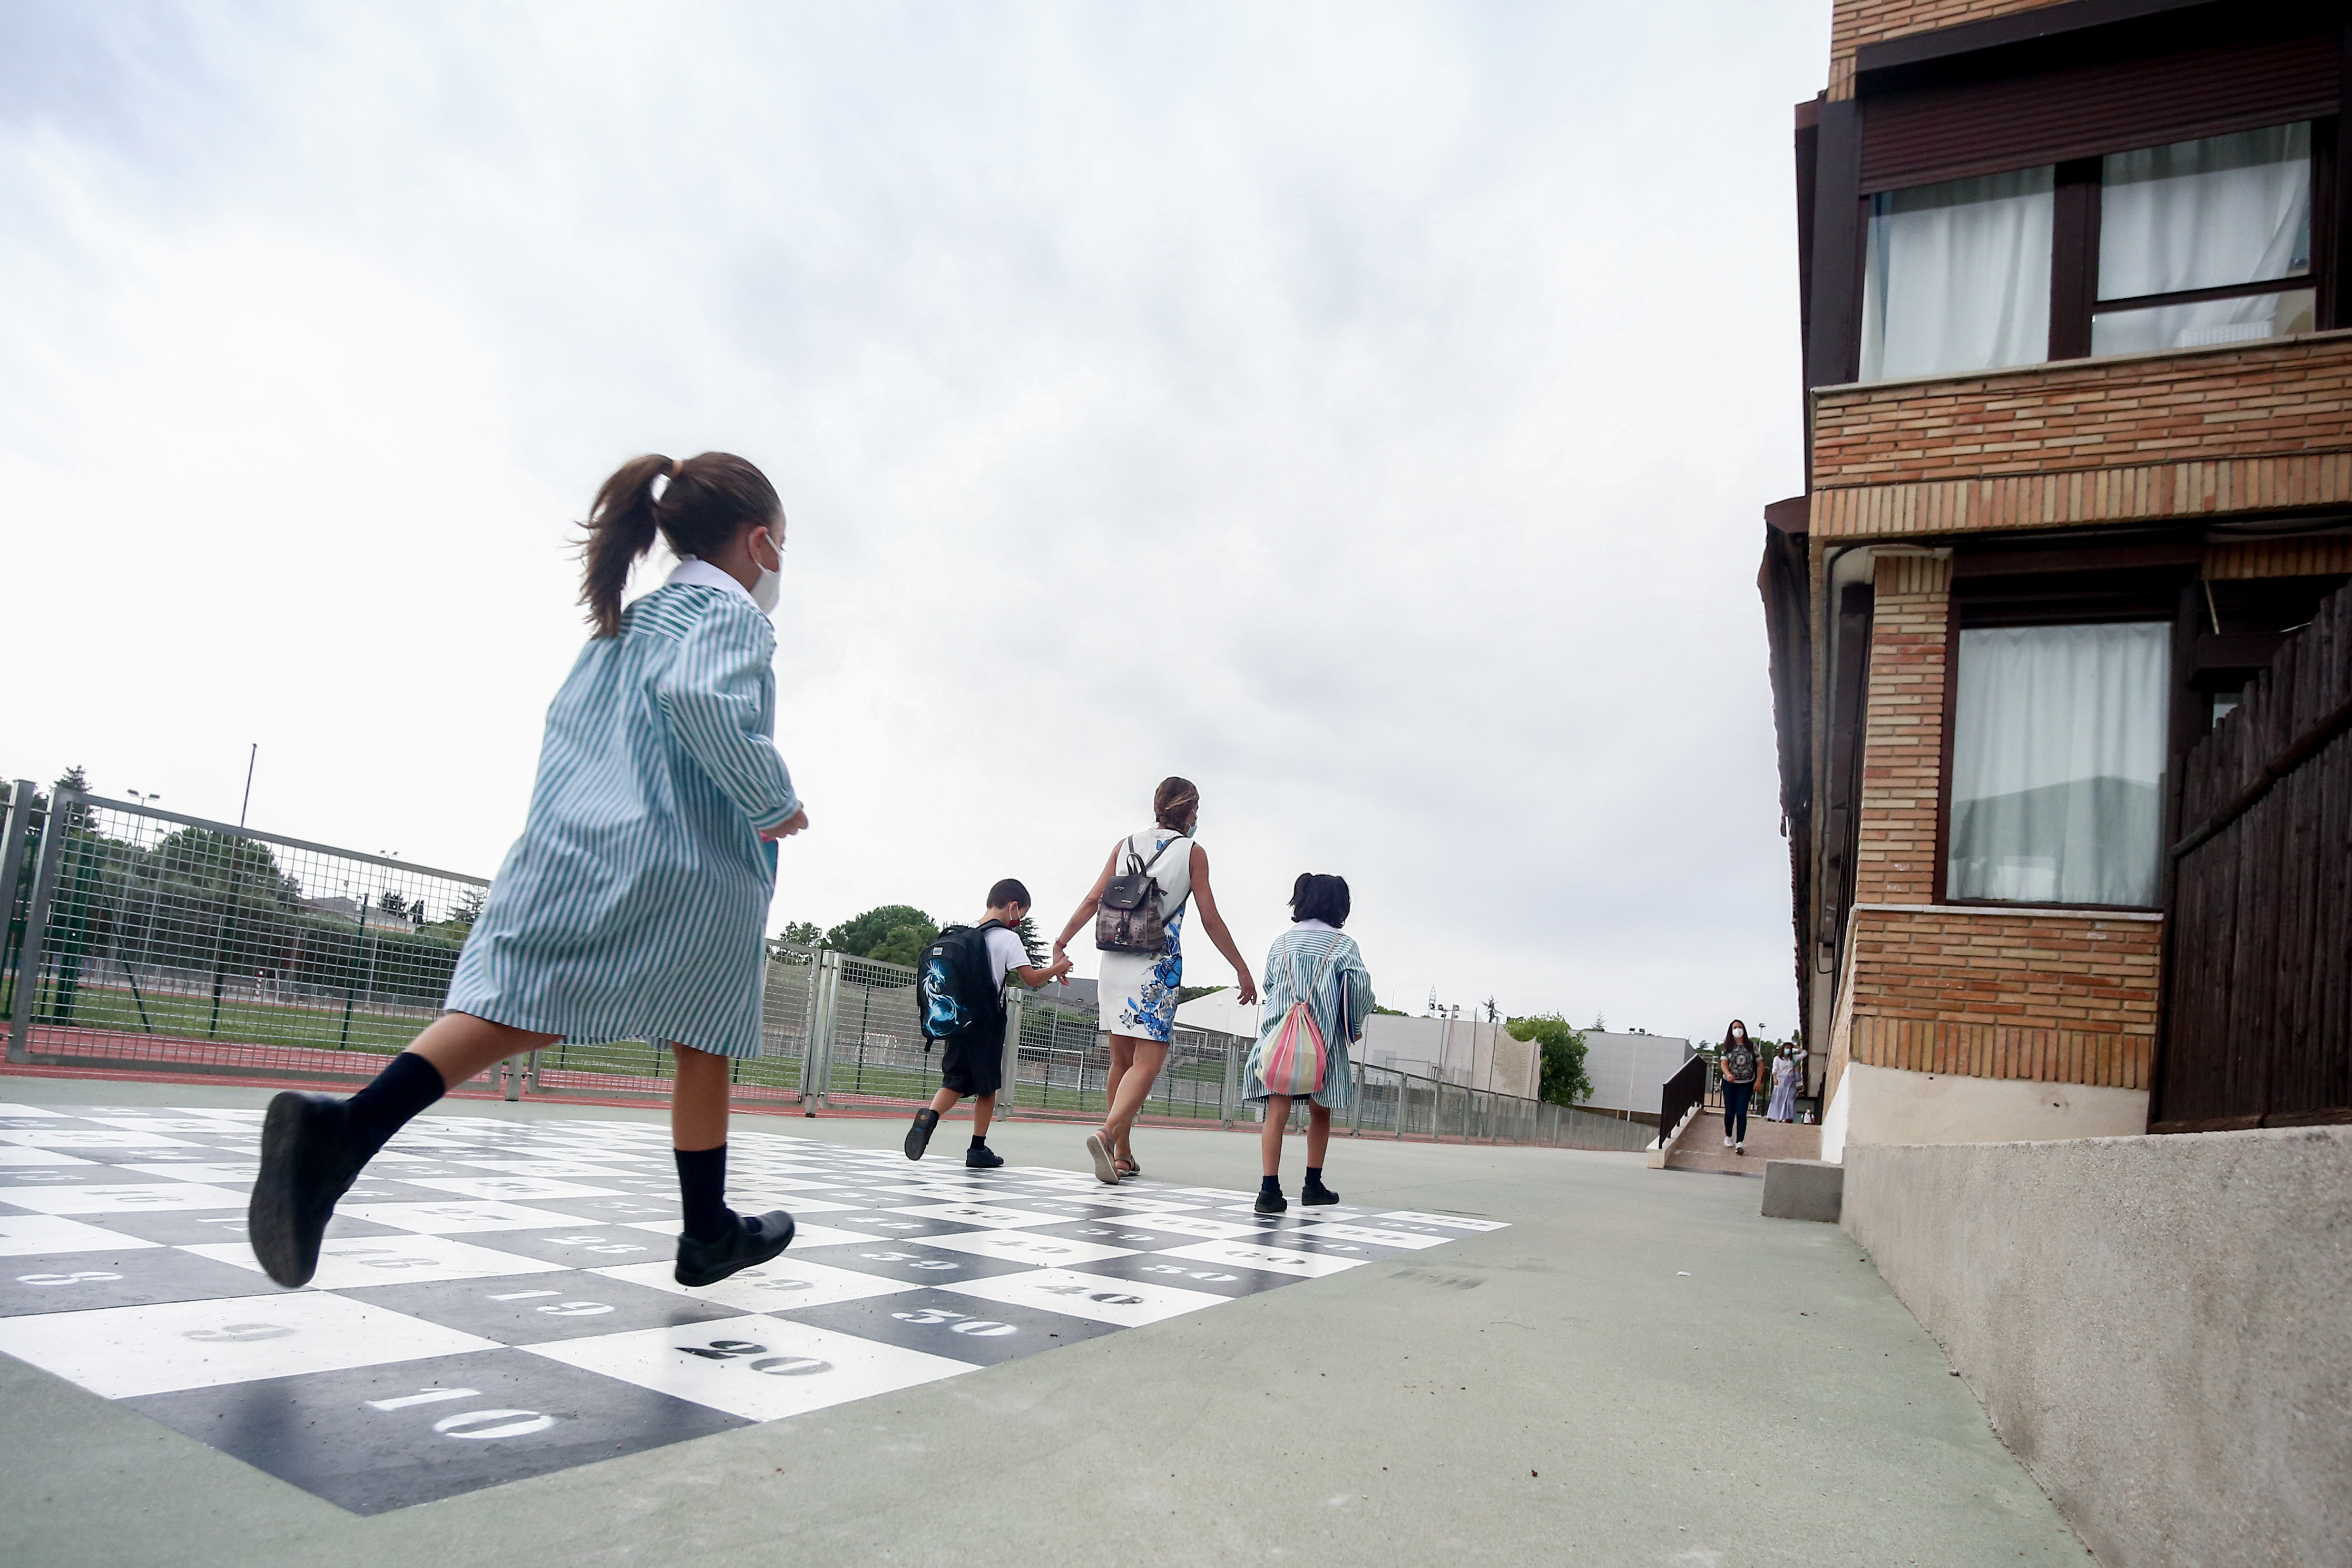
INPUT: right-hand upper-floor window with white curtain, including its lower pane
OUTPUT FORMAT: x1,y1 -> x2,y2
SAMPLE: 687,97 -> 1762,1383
2091,124 -> 2317,355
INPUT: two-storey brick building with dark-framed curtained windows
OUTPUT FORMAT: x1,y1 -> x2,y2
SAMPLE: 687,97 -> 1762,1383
1759,0 -> 2352,1159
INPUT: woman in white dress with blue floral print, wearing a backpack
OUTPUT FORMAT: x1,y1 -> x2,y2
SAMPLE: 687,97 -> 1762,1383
1054,778 -> 1258,1185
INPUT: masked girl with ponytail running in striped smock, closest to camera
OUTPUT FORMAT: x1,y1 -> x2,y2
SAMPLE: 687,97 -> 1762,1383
247,452 -> 809,1288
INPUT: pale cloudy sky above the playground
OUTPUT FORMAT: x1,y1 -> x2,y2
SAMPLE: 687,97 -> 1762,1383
0,0 -> 1828,1034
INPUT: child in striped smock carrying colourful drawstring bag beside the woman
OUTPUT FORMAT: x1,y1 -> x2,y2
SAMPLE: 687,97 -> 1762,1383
1242,872 -> 1374,1213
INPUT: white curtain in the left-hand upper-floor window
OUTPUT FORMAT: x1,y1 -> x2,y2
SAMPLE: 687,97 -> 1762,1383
1863,164 -> 2051,381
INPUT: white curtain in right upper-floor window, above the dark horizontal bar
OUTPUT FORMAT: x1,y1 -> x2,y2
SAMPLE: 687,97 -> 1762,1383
2098,124 -> 2312,299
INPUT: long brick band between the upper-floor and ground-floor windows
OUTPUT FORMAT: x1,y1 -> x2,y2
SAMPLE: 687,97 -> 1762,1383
1814,331 -> 2352,489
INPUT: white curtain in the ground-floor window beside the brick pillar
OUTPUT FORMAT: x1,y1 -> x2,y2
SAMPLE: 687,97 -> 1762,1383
1945,623 -> 2171,905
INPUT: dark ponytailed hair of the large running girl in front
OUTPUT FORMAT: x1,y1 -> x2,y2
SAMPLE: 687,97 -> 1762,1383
581,452 -> 783,637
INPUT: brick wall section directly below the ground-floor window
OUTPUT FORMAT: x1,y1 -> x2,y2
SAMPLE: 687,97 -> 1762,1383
1849,907 -> 2164,1089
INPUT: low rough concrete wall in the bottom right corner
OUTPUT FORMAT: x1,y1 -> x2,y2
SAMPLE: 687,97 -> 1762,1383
1844,1126 -> 2352,1568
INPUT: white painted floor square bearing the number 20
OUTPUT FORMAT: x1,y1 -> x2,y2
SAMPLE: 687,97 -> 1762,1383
524,1317 -> 972,1420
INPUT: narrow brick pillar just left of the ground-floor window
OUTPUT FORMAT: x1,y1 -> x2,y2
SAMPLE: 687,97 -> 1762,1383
1854,555 -> 1952,903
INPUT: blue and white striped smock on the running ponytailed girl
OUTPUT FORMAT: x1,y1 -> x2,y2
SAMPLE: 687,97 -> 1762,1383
447,560 -> 800,1055
